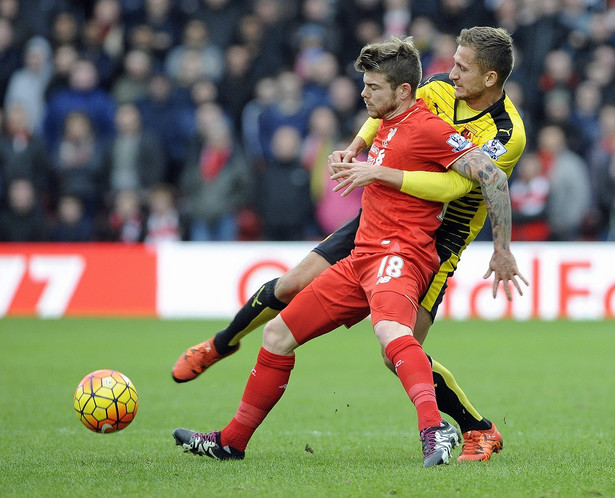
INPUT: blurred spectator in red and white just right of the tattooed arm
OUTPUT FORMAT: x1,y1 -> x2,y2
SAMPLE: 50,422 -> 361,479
510,153 -> 550,241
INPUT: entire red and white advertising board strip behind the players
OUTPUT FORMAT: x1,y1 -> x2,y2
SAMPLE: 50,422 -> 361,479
0,242 -> 615,320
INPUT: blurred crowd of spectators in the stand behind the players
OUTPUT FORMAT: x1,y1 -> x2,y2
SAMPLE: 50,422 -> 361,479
0,0 -> 615,243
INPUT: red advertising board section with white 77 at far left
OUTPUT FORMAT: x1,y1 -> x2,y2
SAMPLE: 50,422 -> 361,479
0,244 -> 156,317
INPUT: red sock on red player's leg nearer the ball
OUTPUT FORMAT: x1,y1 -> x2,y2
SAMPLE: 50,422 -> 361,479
220,348 -> 296,451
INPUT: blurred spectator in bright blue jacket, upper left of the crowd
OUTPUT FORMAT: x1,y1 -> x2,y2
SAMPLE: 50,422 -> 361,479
43,59 -> 115,150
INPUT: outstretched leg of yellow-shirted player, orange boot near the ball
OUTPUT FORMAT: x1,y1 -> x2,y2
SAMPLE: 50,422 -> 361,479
173,216 -> 359,382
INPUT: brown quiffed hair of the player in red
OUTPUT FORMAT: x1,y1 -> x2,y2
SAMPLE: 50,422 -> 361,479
354,36 -> 423,95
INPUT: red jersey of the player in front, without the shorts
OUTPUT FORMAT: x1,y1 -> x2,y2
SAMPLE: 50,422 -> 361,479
353,99 -> 476,278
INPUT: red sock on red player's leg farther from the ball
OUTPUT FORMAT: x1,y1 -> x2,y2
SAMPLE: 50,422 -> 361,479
385,335 -> 442,431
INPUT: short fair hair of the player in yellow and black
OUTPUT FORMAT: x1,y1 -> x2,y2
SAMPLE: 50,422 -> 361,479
457,26 -> 515,86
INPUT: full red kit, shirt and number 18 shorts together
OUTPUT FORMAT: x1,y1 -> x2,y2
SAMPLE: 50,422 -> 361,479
280,97 -> 475,338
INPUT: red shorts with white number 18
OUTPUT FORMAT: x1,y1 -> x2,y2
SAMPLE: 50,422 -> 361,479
280,254 -> 428,344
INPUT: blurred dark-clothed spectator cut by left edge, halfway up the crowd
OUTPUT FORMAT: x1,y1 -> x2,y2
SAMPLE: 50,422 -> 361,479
0,102 -> 54,209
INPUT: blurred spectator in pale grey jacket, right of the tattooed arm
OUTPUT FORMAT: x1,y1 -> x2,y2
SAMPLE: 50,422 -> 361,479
538,126 -> 591,241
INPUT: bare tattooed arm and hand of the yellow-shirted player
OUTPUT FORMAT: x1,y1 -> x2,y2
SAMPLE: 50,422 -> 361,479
451,149 -> 528,301
